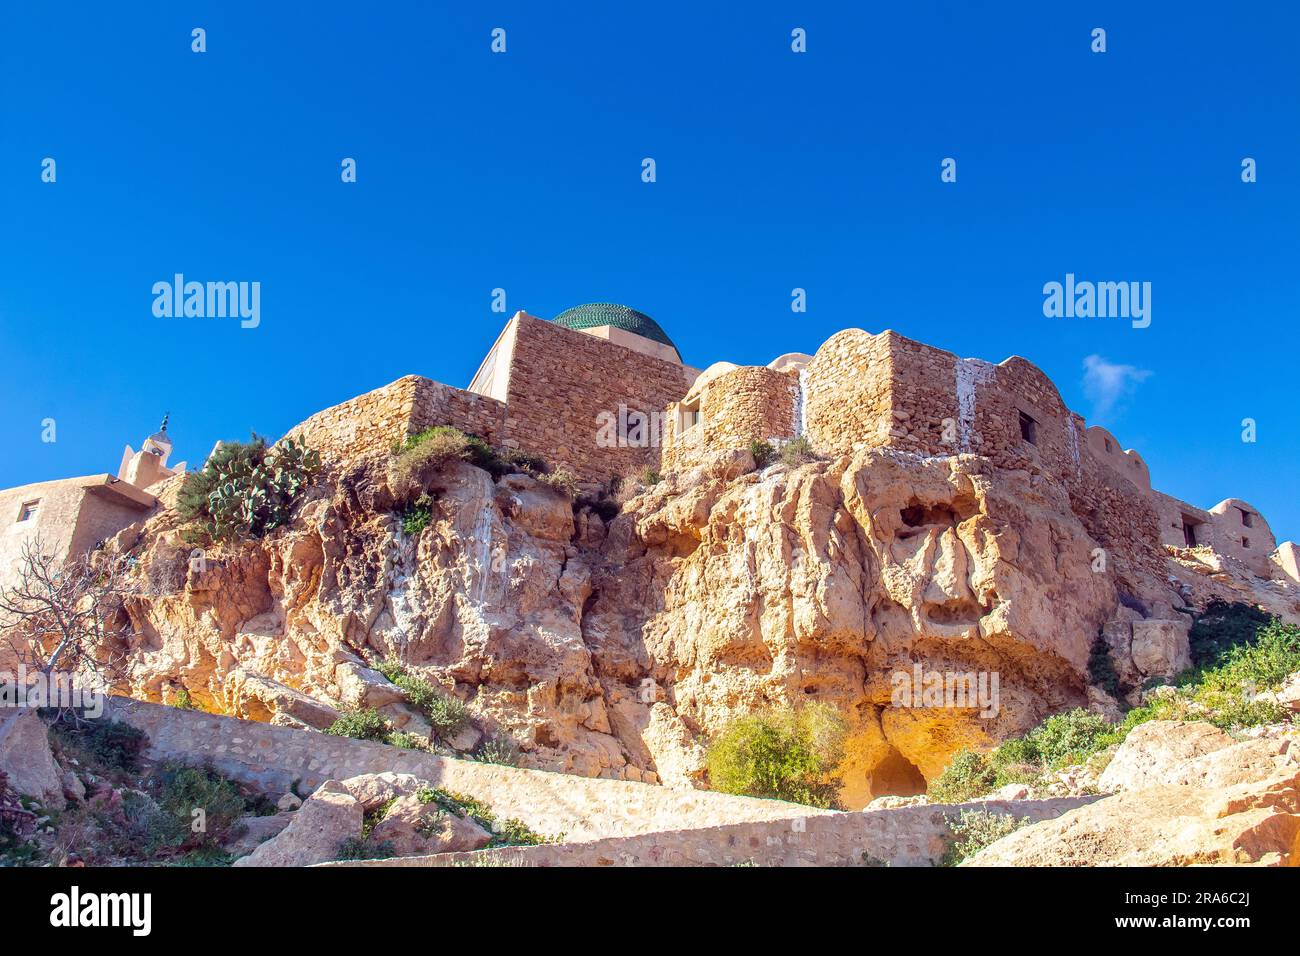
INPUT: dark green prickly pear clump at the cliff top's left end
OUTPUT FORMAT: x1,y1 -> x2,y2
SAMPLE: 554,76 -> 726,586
177,434 -> 321,544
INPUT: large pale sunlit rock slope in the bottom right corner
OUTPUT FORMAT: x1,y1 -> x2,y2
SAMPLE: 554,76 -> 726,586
962,770 -> 1300,866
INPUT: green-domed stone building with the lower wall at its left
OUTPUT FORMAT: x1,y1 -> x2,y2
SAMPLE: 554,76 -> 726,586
289,303 -> 699,483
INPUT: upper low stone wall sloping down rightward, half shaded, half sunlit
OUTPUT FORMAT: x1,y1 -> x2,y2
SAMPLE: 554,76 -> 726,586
107,697 -> 826,840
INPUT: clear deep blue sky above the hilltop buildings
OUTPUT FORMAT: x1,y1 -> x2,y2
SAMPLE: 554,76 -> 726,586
0,0 -> 1300,540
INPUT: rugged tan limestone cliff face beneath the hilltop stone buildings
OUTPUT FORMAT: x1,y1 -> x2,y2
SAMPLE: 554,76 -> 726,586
98,449 -> 1289,806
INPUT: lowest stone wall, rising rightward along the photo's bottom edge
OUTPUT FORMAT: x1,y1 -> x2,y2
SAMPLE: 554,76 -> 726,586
325,796 -> 1101,866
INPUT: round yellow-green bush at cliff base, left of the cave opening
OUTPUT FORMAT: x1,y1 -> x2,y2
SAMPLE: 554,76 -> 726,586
707,704 -> 846,808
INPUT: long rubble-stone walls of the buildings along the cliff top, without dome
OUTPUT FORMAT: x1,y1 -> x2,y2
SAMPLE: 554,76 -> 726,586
271,313 -> 1277,587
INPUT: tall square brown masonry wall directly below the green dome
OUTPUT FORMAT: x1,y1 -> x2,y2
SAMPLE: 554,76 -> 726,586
502,316 -> 693,481
